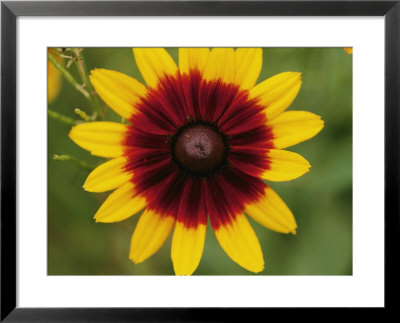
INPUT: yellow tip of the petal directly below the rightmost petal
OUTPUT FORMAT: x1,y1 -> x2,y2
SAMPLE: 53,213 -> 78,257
261,149 -> 311,182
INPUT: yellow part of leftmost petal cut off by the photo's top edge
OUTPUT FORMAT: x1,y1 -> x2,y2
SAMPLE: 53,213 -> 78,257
133,48 -> 178,87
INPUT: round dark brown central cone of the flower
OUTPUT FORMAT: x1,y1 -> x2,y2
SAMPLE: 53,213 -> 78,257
172,123 -> 228,177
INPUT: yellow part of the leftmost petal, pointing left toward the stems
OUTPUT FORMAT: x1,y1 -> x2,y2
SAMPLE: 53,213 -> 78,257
69,121 -> 127,158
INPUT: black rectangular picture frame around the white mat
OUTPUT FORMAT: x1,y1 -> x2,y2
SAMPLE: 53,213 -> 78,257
0,0 -> 400,322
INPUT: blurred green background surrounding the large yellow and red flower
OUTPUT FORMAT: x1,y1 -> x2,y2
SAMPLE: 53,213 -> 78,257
48,48 -> 352,275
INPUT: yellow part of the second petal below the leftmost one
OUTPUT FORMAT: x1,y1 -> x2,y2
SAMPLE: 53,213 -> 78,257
94,182 -> 147,223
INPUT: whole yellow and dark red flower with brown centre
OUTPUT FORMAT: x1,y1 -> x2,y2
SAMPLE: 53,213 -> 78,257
70,48 -> 324,275
